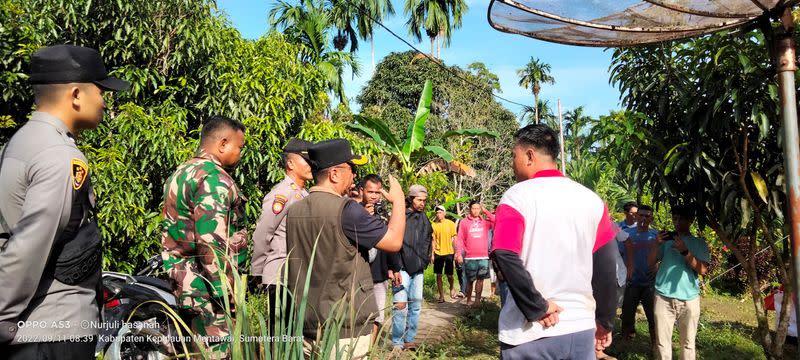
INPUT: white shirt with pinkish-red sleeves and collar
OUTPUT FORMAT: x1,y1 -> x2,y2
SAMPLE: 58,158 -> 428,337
492,170 -> 616,345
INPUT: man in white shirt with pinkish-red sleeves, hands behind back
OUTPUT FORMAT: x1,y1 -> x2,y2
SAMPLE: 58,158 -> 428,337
491,125 -> 617,360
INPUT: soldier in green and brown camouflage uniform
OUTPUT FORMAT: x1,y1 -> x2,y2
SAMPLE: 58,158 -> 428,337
161,117 -> 247,357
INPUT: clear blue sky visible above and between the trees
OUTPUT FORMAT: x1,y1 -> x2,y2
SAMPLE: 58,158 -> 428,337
217,0 -> 619,116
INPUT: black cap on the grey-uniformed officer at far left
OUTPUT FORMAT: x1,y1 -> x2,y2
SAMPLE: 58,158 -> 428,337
29,45 -> 130,91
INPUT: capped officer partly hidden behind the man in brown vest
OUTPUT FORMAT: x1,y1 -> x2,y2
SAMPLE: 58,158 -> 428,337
251,139 -> 313,323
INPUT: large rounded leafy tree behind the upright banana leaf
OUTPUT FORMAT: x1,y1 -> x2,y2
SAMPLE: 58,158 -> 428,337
357,52 -> 519,212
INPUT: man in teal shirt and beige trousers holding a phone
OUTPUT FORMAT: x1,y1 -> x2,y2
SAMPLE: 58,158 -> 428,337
648,205 -> 709,360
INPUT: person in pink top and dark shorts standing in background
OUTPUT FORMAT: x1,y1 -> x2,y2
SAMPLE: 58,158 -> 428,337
455,200 -> 494,306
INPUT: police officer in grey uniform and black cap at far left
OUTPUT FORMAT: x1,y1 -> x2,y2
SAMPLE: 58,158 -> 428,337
0,45 -> 129,359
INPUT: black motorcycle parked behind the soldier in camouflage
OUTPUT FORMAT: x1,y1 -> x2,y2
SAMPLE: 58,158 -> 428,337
95,255 -> 184,360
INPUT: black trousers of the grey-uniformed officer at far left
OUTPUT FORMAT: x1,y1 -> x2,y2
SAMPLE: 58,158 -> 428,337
5,338 -> 97,360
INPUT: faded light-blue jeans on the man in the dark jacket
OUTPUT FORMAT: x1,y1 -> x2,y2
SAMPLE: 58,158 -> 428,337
392,270 -> 425,347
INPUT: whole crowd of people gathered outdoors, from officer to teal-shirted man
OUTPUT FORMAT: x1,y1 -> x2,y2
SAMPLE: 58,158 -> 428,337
0,45 -> 709,359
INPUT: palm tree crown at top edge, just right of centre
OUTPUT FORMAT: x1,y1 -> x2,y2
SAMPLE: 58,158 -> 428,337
405,0 -> 469,56
